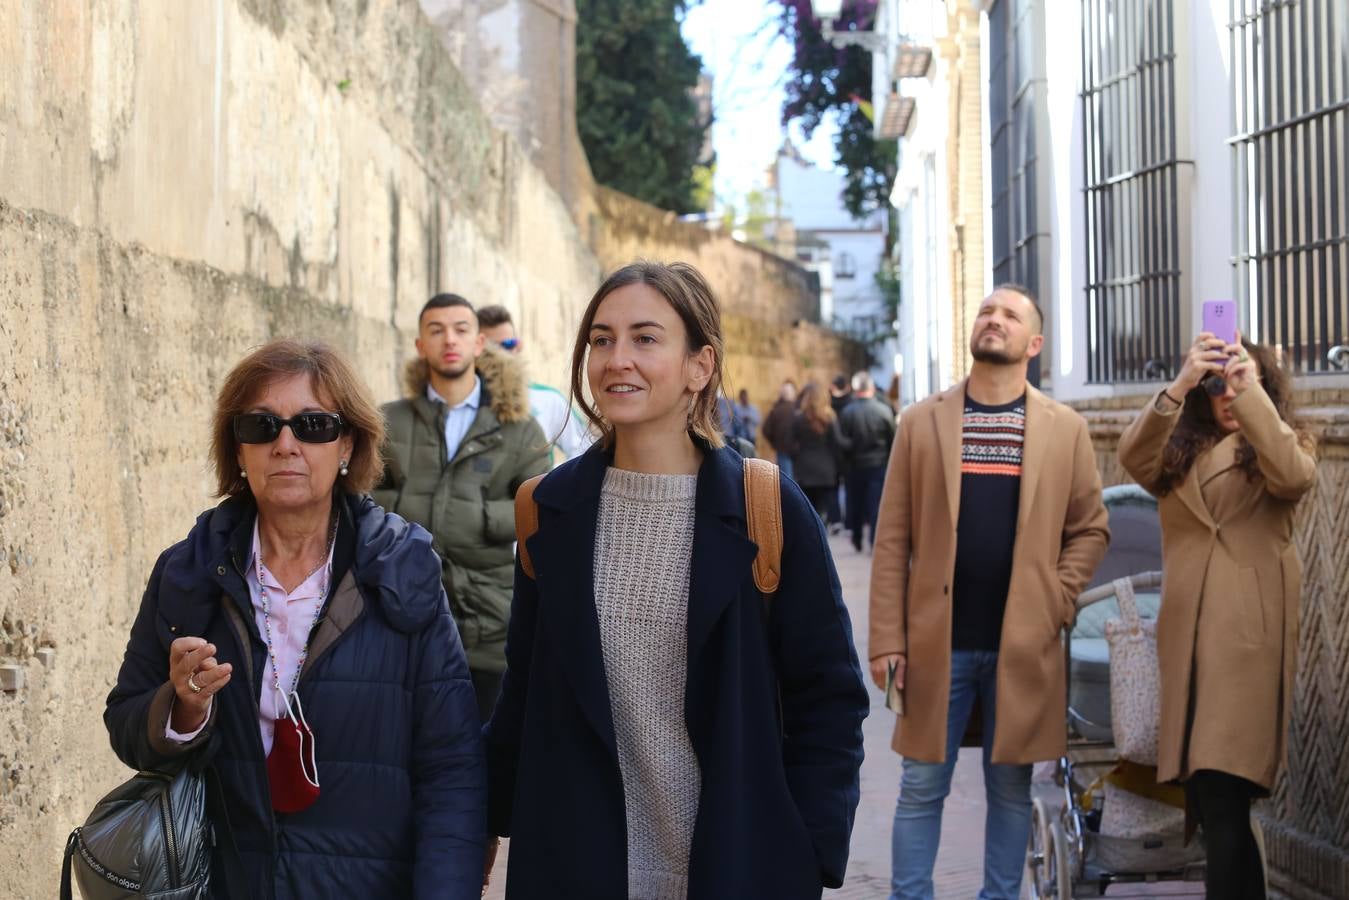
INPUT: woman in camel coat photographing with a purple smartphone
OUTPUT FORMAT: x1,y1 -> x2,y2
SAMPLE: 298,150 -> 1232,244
1120,331 -> 1317,899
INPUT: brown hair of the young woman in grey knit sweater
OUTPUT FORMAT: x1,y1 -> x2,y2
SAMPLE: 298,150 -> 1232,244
572,259 -> 726,447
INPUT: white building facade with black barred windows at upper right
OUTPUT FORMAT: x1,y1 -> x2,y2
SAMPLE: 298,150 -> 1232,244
983,0 -> 1349,399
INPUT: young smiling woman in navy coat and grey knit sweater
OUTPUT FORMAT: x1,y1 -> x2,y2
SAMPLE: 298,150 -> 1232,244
486,263 -> 867,900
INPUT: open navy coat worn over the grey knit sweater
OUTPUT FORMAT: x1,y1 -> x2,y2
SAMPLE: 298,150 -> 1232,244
486,447 -> 867,900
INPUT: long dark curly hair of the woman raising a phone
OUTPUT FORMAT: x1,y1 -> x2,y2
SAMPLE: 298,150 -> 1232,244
1157,340 -> 1313,495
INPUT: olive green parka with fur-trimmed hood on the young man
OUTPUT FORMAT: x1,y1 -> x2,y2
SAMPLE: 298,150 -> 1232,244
371,348 -> 548,672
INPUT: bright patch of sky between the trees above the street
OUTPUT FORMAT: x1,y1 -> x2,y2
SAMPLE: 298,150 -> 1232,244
683,0 -> 835,205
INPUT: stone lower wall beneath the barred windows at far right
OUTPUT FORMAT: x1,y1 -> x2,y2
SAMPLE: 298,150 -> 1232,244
1075,390 -> 1349,900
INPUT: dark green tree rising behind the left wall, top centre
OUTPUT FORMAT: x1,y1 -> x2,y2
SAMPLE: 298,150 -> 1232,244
576,0 -> 712,213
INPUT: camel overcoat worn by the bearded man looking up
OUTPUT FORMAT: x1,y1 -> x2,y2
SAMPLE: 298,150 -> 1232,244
869,382 -> 1110,764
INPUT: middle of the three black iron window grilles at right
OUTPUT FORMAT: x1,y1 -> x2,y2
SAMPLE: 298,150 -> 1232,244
1082,0 -> 1191,383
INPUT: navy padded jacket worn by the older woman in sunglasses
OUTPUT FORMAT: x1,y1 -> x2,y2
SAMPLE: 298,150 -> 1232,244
104,495 -> 486,900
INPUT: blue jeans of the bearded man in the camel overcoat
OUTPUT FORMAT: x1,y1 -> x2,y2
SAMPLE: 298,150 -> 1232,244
890,650 -> 1031,900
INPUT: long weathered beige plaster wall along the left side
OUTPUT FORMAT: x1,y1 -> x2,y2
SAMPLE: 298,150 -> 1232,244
0,0 -> 863,897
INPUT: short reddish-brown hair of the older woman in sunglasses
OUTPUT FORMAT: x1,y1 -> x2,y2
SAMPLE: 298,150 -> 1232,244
210,339 -> 384,497
